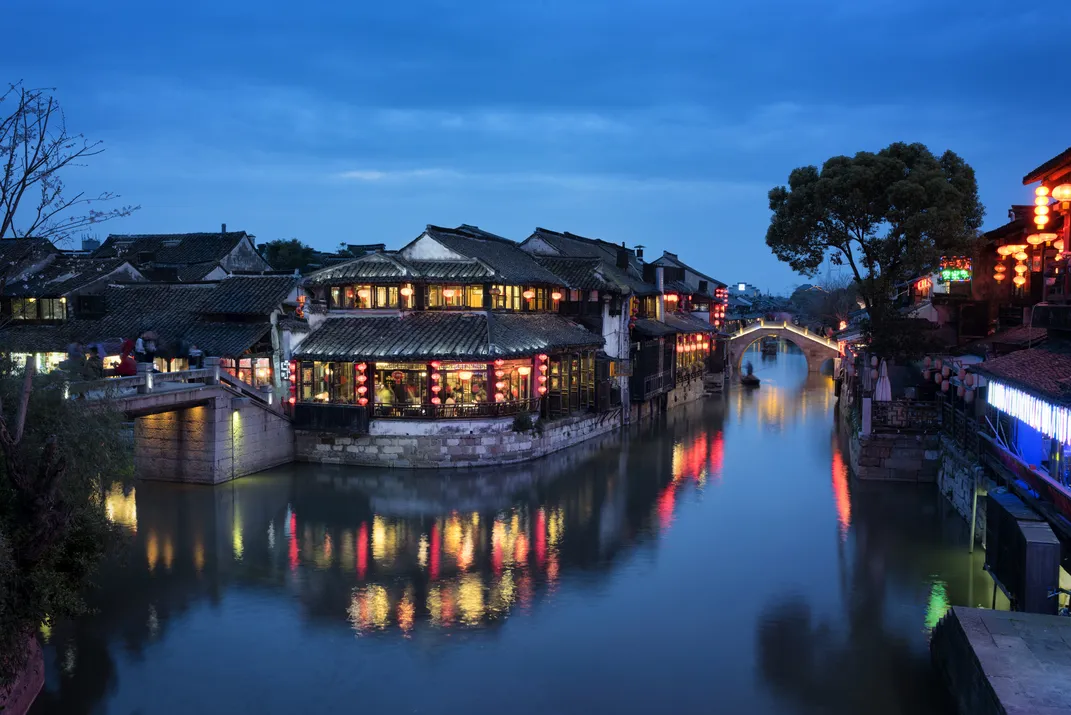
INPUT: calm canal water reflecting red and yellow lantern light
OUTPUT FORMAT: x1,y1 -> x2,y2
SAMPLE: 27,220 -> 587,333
32,346 -> 992,715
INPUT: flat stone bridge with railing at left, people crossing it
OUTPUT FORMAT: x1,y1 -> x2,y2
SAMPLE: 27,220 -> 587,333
69,363 -> 293,484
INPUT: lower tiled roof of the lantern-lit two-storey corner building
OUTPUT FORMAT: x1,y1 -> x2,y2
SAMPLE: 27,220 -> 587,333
296,311 -> 602,361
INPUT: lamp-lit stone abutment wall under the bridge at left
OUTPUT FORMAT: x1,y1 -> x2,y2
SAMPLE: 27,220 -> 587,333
134,393 -> 293,484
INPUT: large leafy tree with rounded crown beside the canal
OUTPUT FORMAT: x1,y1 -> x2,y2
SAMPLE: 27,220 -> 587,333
766,142 -> 985,352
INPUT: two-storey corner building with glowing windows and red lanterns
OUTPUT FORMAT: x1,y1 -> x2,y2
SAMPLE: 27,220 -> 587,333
291,226 -> 619,420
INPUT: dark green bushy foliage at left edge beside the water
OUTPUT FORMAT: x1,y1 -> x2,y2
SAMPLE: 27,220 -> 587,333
0,366 -> 130,685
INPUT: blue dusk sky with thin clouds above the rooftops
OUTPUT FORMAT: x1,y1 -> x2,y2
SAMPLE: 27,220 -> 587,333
3,0 -> 1071,292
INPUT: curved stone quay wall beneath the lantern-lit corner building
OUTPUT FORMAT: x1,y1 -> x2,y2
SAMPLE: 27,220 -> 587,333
295,409 -> 622,469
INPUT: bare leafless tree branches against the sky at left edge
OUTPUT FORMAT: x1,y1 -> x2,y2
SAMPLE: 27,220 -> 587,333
0,82 -> 138,243
